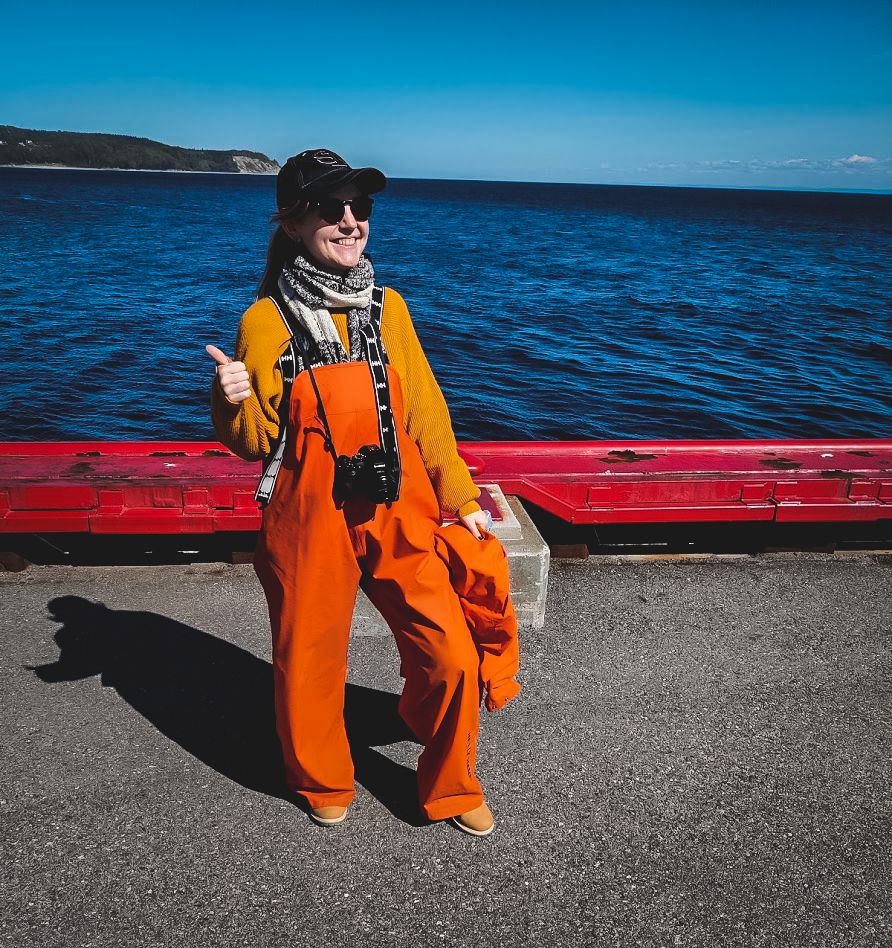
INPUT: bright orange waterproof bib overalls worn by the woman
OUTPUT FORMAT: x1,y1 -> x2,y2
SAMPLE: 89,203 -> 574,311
254,361 -> 483,820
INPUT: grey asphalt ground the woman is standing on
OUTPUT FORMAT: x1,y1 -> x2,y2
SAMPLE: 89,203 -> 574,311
0,554 -> 892,948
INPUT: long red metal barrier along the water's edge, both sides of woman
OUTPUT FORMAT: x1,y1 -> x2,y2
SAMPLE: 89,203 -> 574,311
0,440 -> 892,534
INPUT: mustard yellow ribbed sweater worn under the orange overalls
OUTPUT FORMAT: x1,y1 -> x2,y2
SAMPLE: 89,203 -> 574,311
211,289 -> 480,516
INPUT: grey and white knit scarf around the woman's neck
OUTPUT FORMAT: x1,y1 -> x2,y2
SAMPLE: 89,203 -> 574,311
279,252 -> 375,365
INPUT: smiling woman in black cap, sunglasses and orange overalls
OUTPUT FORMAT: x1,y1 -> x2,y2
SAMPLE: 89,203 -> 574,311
207,149 -> 495,835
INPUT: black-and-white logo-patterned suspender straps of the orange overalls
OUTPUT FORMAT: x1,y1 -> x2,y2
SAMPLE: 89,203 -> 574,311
254,286 -> 402,507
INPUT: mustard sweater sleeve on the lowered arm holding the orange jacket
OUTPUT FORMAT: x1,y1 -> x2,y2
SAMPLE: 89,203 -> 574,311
381,289 -> 480,516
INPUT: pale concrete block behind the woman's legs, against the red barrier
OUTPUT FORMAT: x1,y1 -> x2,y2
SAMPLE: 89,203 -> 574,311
352,484 -> 549,636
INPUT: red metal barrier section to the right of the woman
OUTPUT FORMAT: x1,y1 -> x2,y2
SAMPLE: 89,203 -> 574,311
466,440 -> 892,523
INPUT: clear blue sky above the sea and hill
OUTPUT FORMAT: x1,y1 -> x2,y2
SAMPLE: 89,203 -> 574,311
0,0 -> 892,190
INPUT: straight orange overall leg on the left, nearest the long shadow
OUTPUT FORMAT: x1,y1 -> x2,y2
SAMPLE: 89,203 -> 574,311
254,529 -> 360,808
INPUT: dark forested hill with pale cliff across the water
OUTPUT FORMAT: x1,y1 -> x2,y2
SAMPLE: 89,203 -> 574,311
0,125 -> 279,174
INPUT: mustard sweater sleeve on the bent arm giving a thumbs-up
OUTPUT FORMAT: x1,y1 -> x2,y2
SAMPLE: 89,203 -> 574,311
211,300 -> 288,461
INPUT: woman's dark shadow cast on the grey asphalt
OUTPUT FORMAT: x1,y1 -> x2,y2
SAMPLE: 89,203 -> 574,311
28,596 -> 427,826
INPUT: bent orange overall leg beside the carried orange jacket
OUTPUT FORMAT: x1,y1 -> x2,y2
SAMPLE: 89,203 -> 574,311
364,518 -> 483,820
